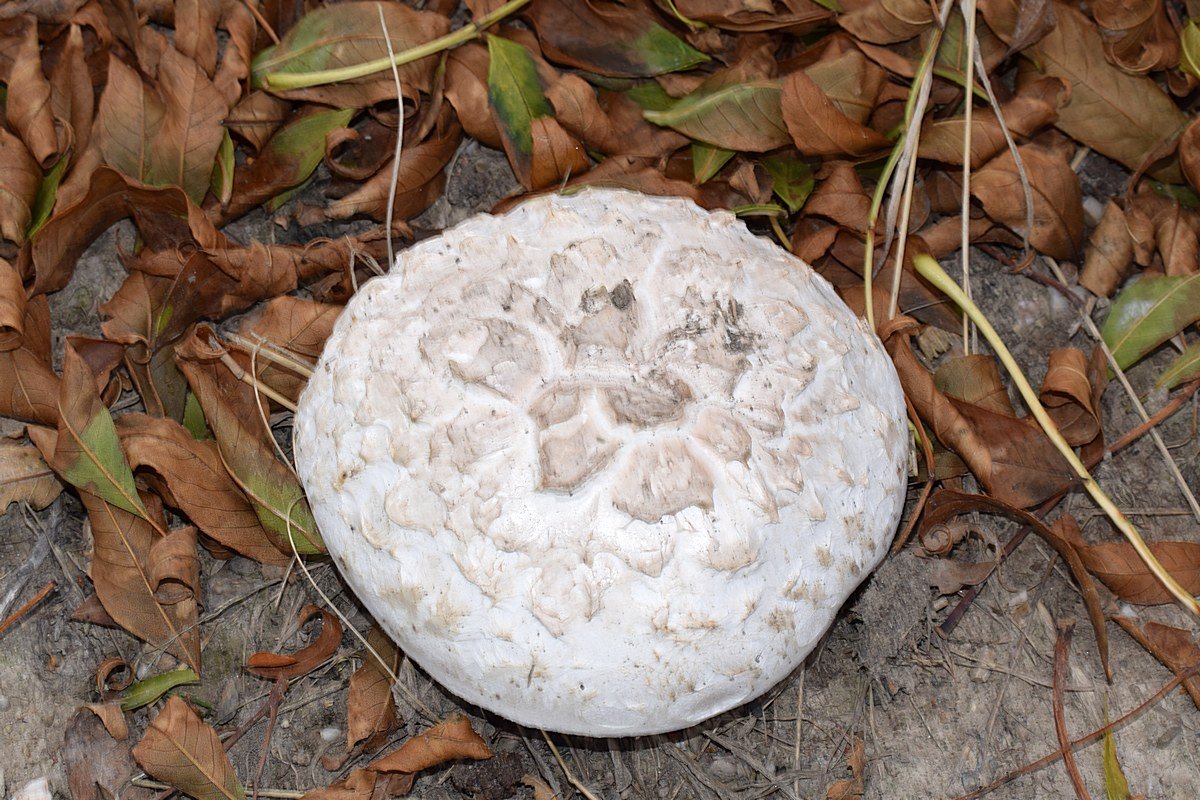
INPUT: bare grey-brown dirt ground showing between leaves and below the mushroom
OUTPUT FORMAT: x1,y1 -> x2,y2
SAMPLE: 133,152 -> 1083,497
0,144 -> 1200,800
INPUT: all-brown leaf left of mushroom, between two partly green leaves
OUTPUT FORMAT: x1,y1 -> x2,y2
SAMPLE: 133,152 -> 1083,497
116,414 -> 292,565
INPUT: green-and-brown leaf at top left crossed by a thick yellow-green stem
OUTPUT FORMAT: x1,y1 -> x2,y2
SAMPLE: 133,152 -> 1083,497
251,2 -> 450,108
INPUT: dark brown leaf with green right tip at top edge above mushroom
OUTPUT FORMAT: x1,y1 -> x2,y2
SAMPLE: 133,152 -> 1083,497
524,0 -> 709,78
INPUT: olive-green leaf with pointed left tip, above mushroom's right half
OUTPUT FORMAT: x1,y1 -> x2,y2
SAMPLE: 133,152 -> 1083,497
642,80 -> 792,152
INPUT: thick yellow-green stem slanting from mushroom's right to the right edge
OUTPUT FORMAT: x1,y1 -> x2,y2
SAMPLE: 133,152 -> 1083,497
913,254 -> 1200,616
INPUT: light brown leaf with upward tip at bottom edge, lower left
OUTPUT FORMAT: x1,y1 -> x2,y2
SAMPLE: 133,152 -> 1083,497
133,696 -> 246,800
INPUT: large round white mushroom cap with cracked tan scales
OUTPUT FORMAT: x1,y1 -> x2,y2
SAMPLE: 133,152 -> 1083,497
295,188 -> 908,736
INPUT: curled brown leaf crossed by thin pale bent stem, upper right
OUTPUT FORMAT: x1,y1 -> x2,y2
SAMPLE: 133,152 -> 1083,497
971,145 -> 1084,259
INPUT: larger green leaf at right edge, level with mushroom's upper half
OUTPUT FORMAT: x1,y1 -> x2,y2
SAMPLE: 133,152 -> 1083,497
1100,272 -> 1200,369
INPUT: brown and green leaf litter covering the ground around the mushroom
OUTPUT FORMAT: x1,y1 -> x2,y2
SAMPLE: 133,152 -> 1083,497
0,0 -> 1200,798
